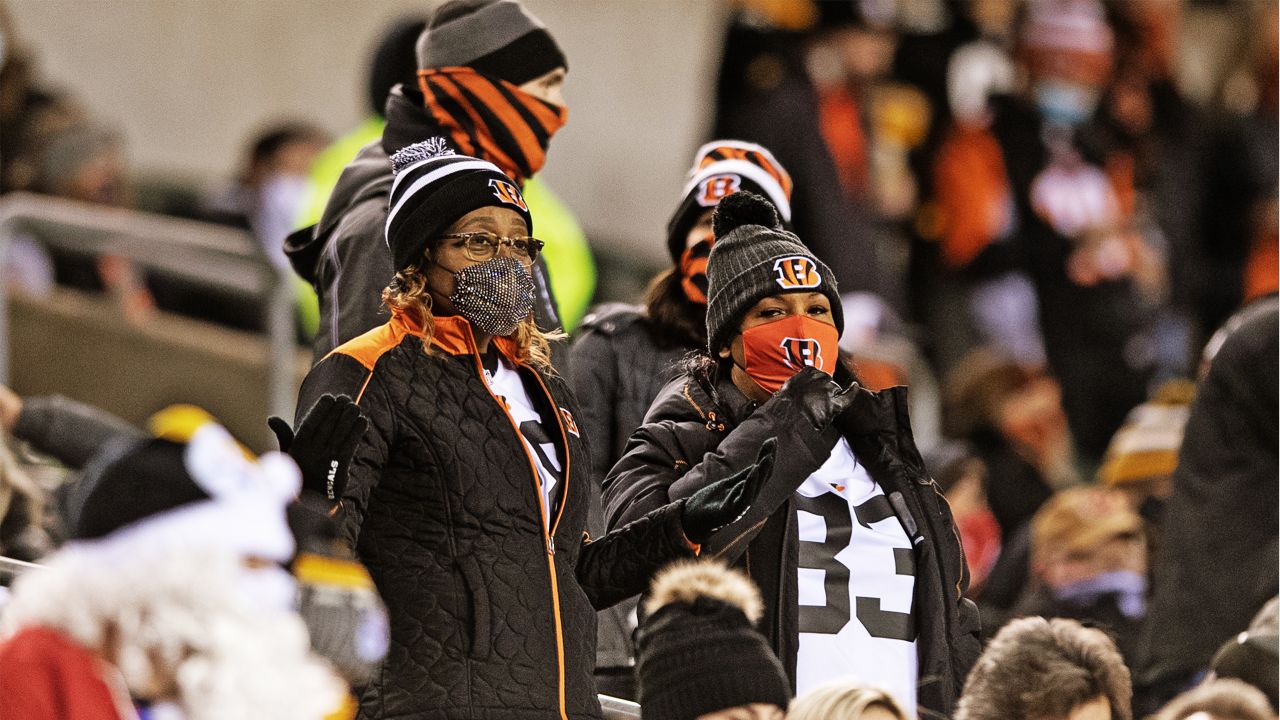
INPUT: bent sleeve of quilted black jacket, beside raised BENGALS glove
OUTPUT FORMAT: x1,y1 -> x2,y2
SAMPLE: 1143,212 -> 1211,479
298,354 -> 396,548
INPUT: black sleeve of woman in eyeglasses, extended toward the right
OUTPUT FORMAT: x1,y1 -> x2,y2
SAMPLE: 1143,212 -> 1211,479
576,502 -> 696,610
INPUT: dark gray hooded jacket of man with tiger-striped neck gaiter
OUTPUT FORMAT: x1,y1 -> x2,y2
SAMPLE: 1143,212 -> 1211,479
284,86 -> 561,363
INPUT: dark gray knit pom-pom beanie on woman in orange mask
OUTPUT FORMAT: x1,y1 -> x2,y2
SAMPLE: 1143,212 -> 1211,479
707,192 -> 845,356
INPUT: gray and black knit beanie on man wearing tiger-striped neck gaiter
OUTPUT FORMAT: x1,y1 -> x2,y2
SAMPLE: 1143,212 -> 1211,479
417,0 -> 568,85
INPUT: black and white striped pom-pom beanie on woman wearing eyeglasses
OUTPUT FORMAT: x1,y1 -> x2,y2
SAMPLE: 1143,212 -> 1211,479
387,137 -> 534,270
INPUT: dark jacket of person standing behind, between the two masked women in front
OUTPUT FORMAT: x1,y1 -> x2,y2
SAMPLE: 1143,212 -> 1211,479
568,302 -> 692,667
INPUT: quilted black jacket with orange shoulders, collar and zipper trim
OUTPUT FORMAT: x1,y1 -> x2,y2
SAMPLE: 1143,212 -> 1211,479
298,315 -> 692,720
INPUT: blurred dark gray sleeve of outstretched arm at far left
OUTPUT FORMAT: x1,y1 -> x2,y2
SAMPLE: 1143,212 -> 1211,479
13,395 -> 146,468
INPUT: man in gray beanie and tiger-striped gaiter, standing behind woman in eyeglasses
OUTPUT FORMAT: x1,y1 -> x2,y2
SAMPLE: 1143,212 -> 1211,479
285,0 -> 581,361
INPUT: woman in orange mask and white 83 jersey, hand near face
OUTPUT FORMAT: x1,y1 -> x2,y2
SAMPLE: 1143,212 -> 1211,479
604,192 -> 979,717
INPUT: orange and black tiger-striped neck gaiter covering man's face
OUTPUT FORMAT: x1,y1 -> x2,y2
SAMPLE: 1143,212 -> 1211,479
417,67 -> 568,186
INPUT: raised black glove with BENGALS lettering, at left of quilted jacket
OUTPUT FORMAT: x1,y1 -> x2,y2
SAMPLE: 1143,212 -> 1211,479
266,395 -> 369,500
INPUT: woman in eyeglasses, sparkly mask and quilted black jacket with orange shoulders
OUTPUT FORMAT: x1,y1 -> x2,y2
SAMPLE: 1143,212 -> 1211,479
298,140 -> 768,720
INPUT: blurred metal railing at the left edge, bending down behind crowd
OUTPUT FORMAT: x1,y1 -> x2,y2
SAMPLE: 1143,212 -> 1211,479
0,192 -> 296,418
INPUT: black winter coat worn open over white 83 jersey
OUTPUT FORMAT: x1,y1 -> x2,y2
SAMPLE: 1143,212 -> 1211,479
604,372 -> 980,717
